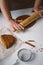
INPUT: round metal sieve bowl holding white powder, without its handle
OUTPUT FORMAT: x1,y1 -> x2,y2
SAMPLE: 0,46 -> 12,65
17,48 -> 32,62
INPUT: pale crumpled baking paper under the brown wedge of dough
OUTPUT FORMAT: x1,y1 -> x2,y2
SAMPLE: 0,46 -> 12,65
0,26 -> 21,60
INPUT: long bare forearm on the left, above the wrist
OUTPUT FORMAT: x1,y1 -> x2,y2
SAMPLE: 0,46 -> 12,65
0,0 -> 12,21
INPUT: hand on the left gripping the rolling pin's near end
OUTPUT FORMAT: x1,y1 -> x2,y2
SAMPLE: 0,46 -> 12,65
9,19 -> 24,31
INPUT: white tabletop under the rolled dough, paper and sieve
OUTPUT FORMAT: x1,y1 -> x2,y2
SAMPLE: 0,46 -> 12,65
0,8 -> 43,65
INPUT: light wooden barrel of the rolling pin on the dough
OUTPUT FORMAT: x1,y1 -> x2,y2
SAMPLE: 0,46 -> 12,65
20,13 -> 40,27
